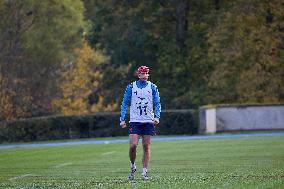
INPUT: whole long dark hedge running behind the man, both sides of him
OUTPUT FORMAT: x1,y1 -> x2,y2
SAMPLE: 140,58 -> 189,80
0,110 -> 198,143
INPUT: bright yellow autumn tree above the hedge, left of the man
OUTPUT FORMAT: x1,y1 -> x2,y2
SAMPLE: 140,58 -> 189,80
52,42 -> 111,115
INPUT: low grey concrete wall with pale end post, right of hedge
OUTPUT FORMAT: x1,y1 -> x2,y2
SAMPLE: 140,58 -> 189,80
199,105 -> 284,133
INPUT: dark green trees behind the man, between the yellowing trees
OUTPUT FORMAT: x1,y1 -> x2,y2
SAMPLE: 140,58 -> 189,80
82,0 -> 220,109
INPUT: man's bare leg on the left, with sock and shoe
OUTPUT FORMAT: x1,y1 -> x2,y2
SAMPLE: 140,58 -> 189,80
128,134 -> 139,180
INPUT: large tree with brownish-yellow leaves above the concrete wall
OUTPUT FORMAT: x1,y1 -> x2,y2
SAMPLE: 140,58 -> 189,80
208,0 -> 284,103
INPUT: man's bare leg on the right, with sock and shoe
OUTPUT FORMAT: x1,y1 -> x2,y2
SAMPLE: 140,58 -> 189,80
142,135 -> 151,179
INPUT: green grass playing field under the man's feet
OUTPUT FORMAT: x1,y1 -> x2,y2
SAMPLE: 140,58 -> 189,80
0,136 -> 284,189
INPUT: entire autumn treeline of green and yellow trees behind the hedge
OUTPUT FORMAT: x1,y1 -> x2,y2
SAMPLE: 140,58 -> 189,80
0,0 -> 284,121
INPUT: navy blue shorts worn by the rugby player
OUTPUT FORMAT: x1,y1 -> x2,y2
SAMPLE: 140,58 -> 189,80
128,122 -> 156,136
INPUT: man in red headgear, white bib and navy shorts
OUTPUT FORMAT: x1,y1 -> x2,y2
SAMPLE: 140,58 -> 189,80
120,66 -> 161,180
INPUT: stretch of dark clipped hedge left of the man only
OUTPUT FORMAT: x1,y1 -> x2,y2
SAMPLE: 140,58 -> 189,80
0,113 -> 123,142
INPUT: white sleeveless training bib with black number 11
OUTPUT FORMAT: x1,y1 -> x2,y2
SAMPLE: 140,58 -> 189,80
130,81 -> 154,123
